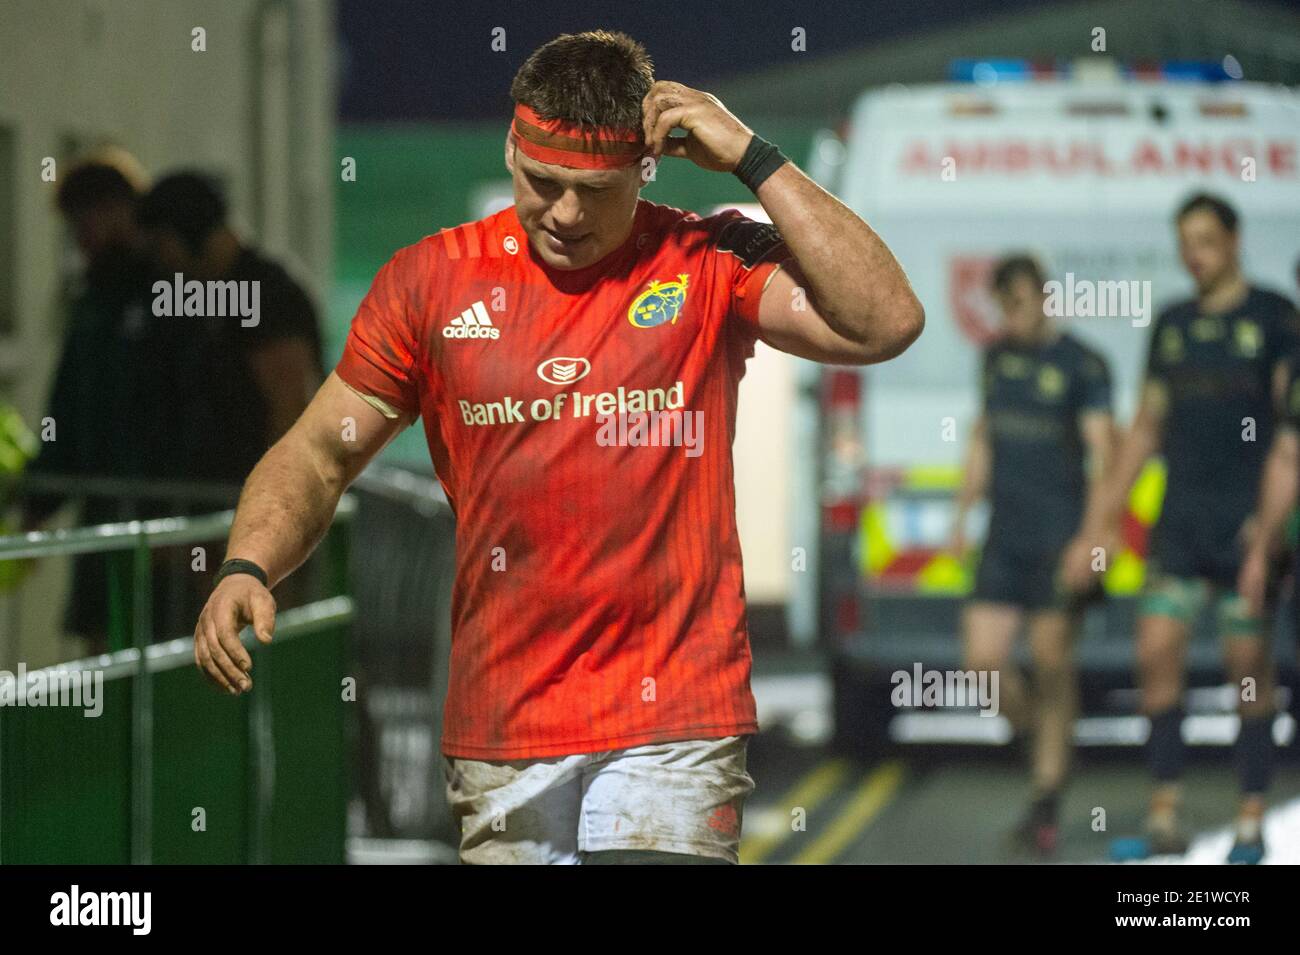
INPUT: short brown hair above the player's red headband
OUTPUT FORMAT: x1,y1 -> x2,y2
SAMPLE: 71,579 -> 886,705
510,30 -> 654,129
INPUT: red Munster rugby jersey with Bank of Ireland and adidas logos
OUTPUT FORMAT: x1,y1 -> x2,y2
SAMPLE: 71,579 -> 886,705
335,200 -> 789,759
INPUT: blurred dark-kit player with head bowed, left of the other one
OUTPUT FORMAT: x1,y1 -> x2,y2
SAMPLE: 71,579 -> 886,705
953,256 -> 1114,854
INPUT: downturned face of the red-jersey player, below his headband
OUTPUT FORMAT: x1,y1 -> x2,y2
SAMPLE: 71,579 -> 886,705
506,143 -> 641,269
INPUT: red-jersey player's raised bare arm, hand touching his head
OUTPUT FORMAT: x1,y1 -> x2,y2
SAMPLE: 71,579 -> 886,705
642,82 -> 926,364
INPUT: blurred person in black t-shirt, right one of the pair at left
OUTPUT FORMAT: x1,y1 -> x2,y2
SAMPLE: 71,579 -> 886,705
138,172 -> 324,483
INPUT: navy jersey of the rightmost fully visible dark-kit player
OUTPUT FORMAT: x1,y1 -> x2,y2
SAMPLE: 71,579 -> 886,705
1147,287 -> 1300,528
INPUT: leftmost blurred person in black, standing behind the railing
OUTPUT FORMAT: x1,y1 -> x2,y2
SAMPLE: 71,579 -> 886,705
22,149 -> 174,652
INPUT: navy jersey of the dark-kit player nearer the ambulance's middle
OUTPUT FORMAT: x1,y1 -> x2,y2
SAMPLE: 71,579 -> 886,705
984,334 -> 1110,552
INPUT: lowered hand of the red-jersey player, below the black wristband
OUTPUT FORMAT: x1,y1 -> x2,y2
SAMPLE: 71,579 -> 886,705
194,574 -> 276,696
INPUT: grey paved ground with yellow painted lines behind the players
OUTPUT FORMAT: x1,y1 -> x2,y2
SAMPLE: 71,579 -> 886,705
741,657 -> 1300,864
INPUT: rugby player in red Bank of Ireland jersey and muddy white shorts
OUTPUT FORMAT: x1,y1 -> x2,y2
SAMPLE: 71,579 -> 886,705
195,31 -> 924,863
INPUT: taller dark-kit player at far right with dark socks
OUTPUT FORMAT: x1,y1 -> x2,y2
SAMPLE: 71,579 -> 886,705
1066,195 -> 1297,863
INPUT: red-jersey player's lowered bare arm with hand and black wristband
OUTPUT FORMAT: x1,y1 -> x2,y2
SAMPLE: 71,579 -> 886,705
194,374 -> 411,695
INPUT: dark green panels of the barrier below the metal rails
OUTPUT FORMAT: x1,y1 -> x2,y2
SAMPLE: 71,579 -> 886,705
0,613 -> 351,864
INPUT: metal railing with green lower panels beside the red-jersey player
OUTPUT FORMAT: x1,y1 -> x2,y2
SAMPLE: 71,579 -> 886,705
0,489 -> 356,863
